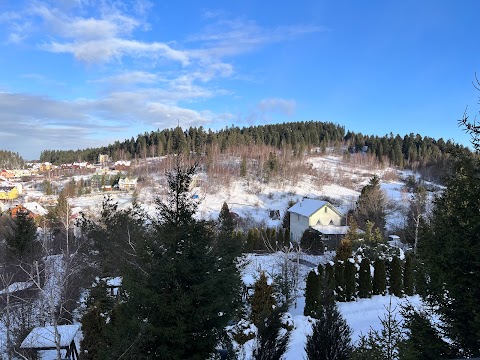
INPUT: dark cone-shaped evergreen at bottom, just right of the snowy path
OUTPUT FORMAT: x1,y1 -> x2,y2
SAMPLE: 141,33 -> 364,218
305,303 -> 352,360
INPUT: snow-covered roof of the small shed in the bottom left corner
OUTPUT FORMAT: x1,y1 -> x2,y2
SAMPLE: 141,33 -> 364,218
20,325 -> 80,349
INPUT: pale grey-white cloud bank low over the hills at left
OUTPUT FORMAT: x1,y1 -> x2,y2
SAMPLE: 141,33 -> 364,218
0,89 -> 230,159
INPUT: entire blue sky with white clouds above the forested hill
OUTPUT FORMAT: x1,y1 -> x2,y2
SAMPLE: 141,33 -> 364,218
0,0 -> 480,159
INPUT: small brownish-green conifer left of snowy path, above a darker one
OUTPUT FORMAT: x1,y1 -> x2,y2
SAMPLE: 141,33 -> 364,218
251,272 -> 277,327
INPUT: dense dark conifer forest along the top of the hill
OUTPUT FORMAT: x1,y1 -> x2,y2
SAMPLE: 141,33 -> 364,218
40,121 -> 468,173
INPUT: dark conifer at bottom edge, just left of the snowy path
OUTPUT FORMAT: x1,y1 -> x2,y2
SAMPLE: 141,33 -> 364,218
253,307 -> 290,360
